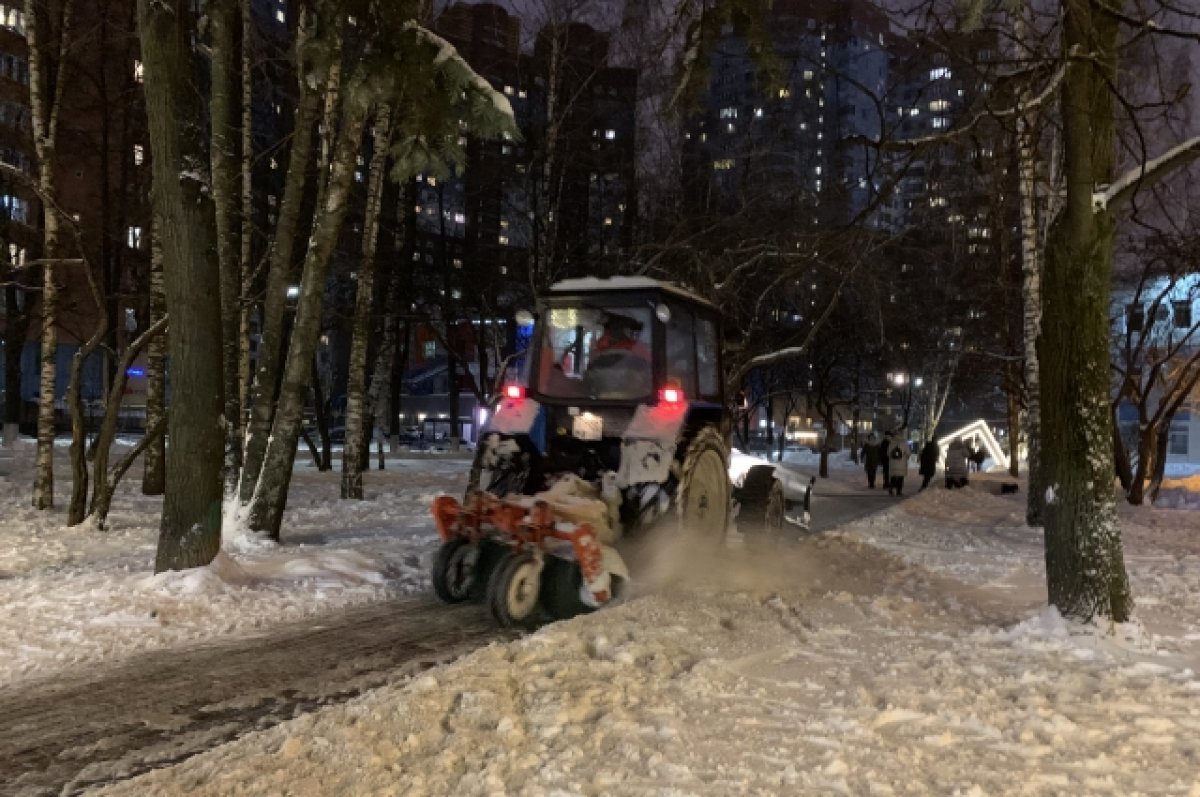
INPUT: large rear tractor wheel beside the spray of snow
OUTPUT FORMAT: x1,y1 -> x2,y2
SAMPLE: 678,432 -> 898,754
676,426 -> 730,544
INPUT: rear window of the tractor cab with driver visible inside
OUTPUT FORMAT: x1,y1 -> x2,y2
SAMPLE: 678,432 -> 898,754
536,306 -> 653,400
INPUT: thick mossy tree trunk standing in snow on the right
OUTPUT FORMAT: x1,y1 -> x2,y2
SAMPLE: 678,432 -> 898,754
1038,0 -> 1133,622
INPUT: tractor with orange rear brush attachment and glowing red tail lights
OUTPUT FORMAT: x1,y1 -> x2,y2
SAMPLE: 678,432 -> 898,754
432,277 -> 812,627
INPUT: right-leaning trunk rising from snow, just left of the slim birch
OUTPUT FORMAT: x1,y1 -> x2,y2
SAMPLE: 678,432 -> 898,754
248,96 -> 367,540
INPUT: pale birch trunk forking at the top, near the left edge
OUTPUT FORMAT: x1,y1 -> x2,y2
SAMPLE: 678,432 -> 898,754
25,0 -> 73,509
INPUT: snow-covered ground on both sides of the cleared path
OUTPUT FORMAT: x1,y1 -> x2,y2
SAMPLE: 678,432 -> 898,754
0,439 -> 1200,797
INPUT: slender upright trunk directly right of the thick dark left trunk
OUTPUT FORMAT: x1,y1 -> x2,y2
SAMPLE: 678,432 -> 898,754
206,0 -> 245,497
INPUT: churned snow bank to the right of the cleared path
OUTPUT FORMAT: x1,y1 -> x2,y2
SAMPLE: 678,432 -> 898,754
106,483 -> 1200,797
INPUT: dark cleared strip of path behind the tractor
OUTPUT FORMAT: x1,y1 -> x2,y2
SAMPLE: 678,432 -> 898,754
0,598 -> 500,795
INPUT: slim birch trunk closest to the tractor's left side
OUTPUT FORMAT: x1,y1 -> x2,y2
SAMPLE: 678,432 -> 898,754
342,104 -> 391,499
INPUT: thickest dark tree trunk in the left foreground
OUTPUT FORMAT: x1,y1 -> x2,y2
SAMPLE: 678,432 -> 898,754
138,0 -> 224,573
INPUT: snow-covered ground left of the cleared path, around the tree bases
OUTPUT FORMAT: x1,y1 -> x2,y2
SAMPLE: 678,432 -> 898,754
0,447 -> 468,684
